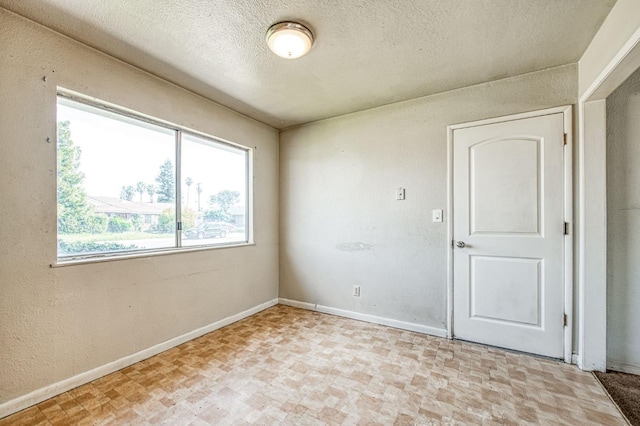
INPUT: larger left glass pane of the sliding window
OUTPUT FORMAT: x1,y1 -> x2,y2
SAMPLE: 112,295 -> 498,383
57,97 -> 176,258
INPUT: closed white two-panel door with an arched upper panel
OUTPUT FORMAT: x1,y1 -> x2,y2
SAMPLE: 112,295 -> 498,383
453,113 -> 564,358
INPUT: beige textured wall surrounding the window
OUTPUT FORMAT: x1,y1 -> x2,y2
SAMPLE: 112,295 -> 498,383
0,9 -> 278,404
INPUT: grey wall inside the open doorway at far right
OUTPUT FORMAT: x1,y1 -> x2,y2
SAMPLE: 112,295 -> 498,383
607,66 -> 640,374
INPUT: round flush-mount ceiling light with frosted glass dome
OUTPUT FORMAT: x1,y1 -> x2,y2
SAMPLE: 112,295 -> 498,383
267,21 -> 313,59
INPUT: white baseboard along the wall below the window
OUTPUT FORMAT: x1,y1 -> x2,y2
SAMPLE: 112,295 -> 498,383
0,299 -> 278,419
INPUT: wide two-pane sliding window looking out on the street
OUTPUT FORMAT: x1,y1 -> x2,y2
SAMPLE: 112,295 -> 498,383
57,92 -> 249,262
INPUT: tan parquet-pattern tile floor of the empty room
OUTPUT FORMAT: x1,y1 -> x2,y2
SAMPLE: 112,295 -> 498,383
0,305 -> 626,426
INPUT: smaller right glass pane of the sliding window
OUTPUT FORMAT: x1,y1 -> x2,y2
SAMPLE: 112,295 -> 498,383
181,133 -> 247,246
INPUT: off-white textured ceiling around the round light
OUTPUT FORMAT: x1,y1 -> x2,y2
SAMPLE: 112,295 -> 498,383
0,0 -> 615,128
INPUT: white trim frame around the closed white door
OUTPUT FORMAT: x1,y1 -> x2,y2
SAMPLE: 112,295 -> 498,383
447,105 -> 574,363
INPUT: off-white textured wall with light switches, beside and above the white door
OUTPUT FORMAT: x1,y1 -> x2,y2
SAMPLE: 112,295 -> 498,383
280,65 -> 578,329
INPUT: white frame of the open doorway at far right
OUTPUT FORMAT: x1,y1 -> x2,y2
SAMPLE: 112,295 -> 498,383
576,25 -> 640,371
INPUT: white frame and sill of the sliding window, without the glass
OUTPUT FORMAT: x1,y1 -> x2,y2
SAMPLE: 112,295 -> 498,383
50,87 -> 255,267
